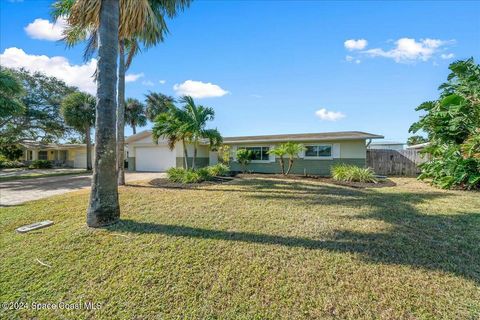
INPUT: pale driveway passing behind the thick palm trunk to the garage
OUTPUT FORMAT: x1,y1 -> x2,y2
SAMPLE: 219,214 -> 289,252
0,172 -> 166,207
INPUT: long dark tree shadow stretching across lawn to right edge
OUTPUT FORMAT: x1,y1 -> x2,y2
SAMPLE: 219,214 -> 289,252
116,179 -> 480,283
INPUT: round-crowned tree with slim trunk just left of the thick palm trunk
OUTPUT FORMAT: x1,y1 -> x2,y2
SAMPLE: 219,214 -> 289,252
61,92 -> 96,170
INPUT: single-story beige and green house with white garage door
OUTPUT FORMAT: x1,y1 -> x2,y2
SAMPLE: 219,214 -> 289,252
126,131 -> 383,175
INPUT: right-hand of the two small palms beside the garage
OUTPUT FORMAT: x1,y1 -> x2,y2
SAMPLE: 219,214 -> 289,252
180,96 -> 223,169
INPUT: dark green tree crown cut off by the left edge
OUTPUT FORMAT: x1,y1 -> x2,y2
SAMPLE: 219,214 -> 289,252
0,68 -> 25,128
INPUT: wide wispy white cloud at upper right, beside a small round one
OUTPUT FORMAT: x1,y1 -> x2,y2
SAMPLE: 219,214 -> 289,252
364,38 -> 454,62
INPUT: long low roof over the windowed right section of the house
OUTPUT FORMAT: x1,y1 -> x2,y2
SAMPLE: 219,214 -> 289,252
223,131 -> 383,144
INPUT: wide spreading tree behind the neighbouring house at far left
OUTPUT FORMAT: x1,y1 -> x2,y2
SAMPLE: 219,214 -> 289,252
0,69 -> 76,143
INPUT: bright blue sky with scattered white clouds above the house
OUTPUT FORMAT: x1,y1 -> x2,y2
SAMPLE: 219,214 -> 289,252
0,0 -> 480,140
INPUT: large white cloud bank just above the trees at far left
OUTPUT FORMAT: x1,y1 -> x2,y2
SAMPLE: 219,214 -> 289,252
0,47 -> 97,94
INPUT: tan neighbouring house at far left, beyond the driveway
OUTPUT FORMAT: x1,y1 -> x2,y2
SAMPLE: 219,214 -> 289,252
20,141 -> 93,168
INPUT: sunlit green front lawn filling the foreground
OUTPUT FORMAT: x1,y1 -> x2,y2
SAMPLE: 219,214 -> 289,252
0,176 -> 480,319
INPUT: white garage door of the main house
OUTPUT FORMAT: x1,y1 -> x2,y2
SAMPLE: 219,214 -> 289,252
135,146 -> 176,171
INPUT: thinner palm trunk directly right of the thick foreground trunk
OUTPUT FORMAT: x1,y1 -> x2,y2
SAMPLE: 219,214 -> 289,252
117,40 -> 126,186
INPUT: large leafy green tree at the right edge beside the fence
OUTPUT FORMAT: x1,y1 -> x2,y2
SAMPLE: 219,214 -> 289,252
410,58 -> 480,189
